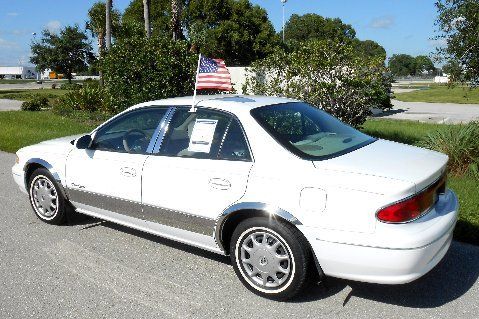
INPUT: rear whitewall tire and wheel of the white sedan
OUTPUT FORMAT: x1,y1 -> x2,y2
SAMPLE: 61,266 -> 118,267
230,217 -> 311,300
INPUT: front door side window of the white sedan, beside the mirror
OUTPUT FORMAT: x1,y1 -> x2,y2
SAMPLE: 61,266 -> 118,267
91,108 -> 167,154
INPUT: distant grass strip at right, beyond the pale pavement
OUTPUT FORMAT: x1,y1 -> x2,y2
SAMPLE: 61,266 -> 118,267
394,85 -> 479,104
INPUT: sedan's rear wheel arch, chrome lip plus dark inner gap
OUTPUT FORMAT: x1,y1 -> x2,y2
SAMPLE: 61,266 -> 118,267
215,202 -> 302,255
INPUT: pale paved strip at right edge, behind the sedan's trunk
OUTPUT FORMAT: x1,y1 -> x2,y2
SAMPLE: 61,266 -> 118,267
375,100 -> 479,123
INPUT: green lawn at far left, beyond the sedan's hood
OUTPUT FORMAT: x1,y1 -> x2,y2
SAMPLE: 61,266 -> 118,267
0,111 -> 96,153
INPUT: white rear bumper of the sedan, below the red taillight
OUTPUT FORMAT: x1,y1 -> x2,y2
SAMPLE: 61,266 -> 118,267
306,190 -> 459,284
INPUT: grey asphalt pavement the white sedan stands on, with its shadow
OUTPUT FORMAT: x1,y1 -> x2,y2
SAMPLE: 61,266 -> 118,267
0,152 -> 479,319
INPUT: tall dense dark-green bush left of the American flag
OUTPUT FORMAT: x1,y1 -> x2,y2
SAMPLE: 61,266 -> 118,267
102,37 -> 198,112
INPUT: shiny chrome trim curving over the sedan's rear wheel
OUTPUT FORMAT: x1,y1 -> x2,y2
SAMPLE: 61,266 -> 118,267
215,202 -> 302,251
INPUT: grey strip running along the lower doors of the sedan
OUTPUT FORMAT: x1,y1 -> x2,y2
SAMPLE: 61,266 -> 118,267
68,188 -> 215,237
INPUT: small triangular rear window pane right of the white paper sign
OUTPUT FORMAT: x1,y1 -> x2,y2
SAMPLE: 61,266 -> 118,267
218,120 -> 251,161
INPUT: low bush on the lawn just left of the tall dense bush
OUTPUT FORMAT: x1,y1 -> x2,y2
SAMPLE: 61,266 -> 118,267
59,85 -> 104,114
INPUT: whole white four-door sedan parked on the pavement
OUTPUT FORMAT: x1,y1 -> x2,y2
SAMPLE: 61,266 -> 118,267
12,95 -> 458,300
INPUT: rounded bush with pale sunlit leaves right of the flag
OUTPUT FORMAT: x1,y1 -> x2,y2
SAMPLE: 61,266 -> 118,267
243,40 -> 391,127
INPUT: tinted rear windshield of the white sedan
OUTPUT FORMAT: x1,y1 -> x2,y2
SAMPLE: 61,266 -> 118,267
251,102 -> 375,160
